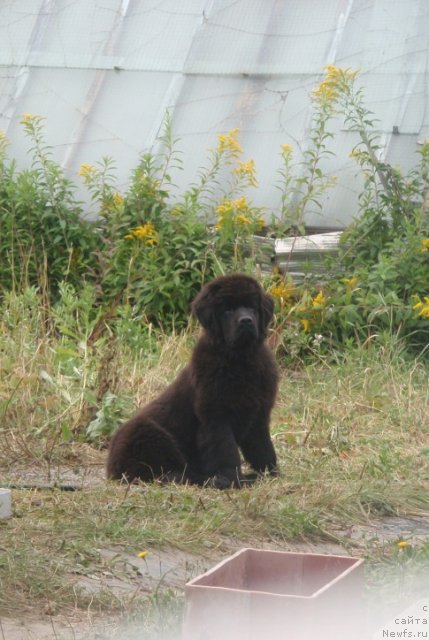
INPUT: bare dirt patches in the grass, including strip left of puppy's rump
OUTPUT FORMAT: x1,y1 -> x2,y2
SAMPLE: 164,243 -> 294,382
0,465 -> 429,640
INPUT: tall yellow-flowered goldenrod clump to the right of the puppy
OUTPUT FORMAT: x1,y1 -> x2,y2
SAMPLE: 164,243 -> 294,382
272,65 -> 429,359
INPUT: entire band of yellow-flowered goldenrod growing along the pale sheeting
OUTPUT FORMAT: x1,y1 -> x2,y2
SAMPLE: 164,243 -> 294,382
0,65 -> 429,352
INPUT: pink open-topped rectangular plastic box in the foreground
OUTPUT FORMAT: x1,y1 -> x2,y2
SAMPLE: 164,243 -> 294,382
183,549 -> 363,640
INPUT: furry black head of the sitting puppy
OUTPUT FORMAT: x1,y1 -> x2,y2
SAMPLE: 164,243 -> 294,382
192,274 -> 274,347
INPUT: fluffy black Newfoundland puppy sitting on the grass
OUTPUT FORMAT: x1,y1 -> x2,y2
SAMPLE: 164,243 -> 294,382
107,274 -> 277,489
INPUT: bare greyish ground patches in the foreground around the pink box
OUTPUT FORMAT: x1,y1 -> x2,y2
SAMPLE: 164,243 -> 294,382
0,516 -> 429,640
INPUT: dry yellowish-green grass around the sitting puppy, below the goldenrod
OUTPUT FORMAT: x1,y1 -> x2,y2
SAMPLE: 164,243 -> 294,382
0,291 -> 429,637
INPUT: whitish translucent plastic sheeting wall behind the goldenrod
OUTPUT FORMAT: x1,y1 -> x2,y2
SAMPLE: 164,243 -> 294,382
0,0 -> 429,228
